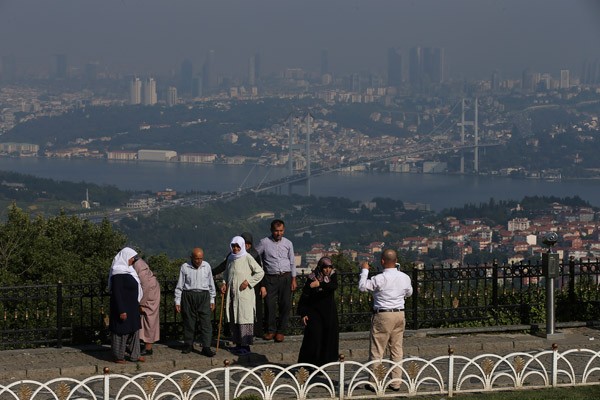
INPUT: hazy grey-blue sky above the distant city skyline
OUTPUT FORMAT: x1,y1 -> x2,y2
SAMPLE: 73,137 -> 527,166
0,0 -> 600,78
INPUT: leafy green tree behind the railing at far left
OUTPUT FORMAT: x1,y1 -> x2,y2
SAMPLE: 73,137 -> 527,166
0,205 -> 126,284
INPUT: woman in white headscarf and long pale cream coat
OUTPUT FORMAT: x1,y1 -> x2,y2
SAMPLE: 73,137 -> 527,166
221,236 -> 265,355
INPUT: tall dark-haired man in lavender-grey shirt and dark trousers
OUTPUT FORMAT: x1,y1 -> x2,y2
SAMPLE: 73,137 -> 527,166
256,219 -> 296,342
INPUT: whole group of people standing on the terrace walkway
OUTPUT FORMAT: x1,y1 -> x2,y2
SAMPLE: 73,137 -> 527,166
109,219 -> 412,384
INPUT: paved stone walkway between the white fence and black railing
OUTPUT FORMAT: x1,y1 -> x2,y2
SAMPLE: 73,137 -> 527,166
0,327 -> 600,384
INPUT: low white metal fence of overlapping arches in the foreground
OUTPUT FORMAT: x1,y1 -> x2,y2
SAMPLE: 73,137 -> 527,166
0,348 -> 600,400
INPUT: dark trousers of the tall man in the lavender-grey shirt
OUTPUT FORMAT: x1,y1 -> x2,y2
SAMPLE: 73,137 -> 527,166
264,273 -> 292,333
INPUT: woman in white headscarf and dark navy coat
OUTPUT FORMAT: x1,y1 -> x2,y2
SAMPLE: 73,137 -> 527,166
108,247 -> 145,364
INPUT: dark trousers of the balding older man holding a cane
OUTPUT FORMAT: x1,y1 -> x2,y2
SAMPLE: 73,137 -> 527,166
181,290 -> 212,347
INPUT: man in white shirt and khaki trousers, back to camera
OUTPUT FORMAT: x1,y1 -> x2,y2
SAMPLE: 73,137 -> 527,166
358,249 -> 413,391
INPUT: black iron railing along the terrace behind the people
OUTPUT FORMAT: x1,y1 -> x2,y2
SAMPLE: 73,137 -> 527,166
0,259 -> 600,349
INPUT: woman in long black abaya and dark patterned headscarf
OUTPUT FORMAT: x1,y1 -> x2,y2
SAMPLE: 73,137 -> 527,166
298,257 -> 339,366
